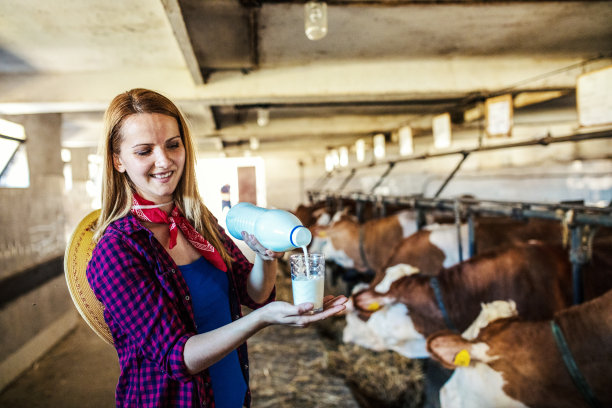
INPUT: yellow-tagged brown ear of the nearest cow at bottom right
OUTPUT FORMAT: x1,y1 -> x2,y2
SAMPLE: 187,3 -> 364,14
427,330 -> 472,369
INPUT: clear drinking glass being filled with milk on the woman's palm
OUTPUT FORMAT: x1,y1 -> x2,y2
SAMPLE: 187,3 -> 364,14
289,254 -> 325,312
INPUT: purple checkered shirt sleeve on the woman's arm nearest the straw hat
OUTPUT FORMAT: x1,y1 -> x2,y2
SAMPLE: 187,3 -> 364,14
88,233 -> 195,382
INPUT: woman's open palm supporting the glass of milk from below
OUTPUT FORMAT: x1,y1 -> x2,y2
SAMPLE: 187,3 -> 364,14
258,295 -> 348,327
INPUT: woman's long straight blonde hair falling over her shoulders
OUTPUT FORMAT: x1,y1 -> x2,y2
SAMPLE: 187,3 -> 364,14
94,88 -> 232,267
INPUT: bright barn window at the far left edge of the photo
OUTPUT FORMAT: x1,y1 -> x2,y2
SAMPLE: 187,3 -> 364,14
0,119 -> 30,188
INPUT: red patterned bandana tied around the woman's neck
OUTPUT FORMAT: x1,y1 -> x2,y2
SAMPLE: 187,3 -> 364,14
130,193 -> 227,272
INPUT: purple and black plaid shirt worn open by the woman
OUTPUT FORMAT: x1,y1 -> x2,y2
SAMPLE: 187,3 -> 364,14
87,214 -> 275,408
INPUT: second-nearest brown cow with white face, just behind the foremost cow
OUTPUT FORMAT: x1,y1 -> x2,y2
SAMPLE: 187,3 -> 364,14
343,241 -> 572,358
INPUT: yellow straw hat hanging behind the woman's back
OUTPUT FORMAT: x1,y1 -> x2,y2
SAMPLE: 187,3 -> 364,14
64,210 -> 113,344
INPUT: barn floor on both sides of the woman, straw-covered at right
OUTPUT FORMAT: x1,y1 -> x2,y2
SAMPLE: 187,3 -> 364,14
0,264 -> 423,408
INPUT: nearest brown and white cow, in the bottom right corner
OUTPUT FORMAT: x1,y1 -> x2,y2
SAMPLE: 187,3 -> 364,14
427,291 -> 612,408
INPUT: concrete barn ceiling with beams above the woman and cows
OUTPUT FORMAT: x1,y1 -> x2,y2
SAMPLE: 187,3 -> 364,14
0,0 -> 612,154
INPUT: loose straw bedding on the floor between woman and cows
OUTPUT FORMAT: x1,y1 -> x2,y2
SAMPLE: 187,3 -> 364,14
249,264 -> 423,408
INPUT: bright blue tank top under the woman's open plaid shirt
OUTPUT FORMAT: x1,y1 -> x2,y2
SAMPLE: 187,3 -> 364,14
179,257 -> 247,408
